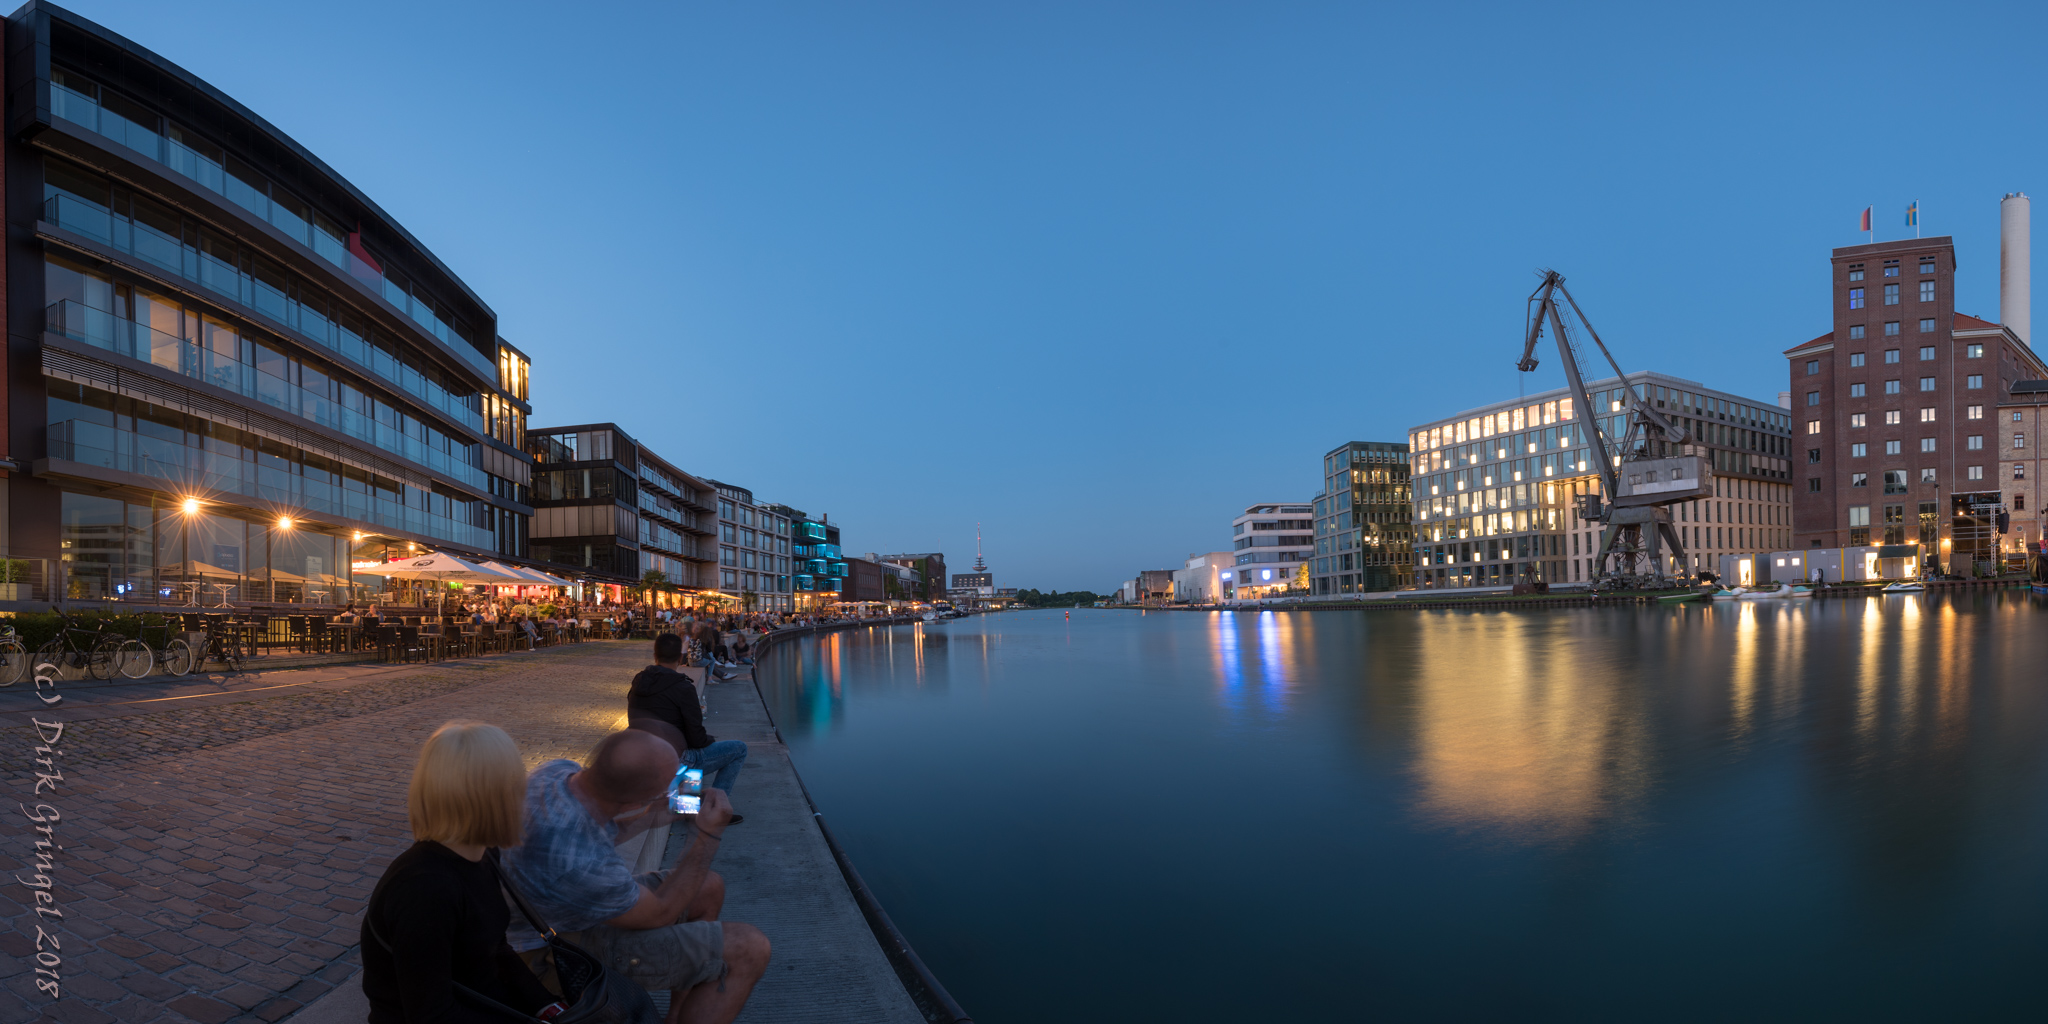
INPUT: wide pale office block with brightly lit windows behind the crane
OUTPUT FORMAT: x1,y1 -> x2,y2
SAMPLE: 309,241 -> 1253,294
1409,373 -> 1792,588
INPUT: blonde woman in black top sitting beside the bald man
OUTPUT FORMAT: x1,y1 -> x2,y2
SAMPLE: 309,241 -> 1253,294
360,721 -> 561,1024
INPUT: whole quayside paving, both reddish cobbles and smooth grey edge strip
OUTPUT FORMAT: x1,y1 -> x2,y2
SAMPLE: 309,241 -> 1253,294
0,643 -> 918,1024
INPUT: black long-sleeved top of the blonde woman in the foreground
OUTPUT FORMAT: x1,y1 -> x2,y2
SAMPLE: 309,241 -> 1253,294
362,842 -> 555,1024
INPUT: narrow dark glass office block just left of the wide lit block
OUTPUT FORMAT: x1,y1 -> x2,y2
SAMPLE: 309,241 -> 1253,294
1309,440 -> 1415,598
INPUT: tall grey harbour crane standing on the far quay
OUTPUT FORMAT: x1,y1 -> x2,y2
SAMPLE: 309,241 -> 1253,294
1516,270 -> 1714,590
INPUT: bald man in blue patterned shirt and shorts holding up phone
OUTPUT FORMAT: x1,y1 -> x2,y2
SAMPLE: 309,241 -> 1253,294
506,729 -> 768,1024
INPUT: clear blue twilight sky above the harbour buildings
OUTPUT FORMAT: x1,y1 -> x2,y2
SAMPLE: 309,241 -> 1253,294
59,0 -> 2048,590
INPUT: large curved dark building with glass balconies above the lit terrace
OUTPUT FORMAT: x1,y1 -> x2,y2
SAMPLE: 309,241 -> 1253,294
16,2 -> 530,600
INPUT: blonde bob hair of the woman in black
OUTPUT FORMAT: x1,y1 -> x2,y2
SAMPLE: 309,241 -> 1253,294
406,721 -> 526,848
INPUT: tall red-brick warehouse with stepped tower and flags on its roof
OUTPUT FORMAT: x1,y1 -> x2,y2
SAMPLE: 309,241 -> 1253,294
1786,236 -> 2048,571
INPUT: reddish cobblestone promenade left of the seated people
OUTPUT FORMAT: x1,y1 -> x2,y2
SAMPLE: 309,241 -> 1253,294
0,643 -> 655,1024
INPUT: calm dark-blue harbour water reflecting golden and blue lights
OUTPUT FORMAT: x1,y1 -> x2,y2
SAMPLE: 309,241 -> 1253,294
739,592 -> 2048,1024
